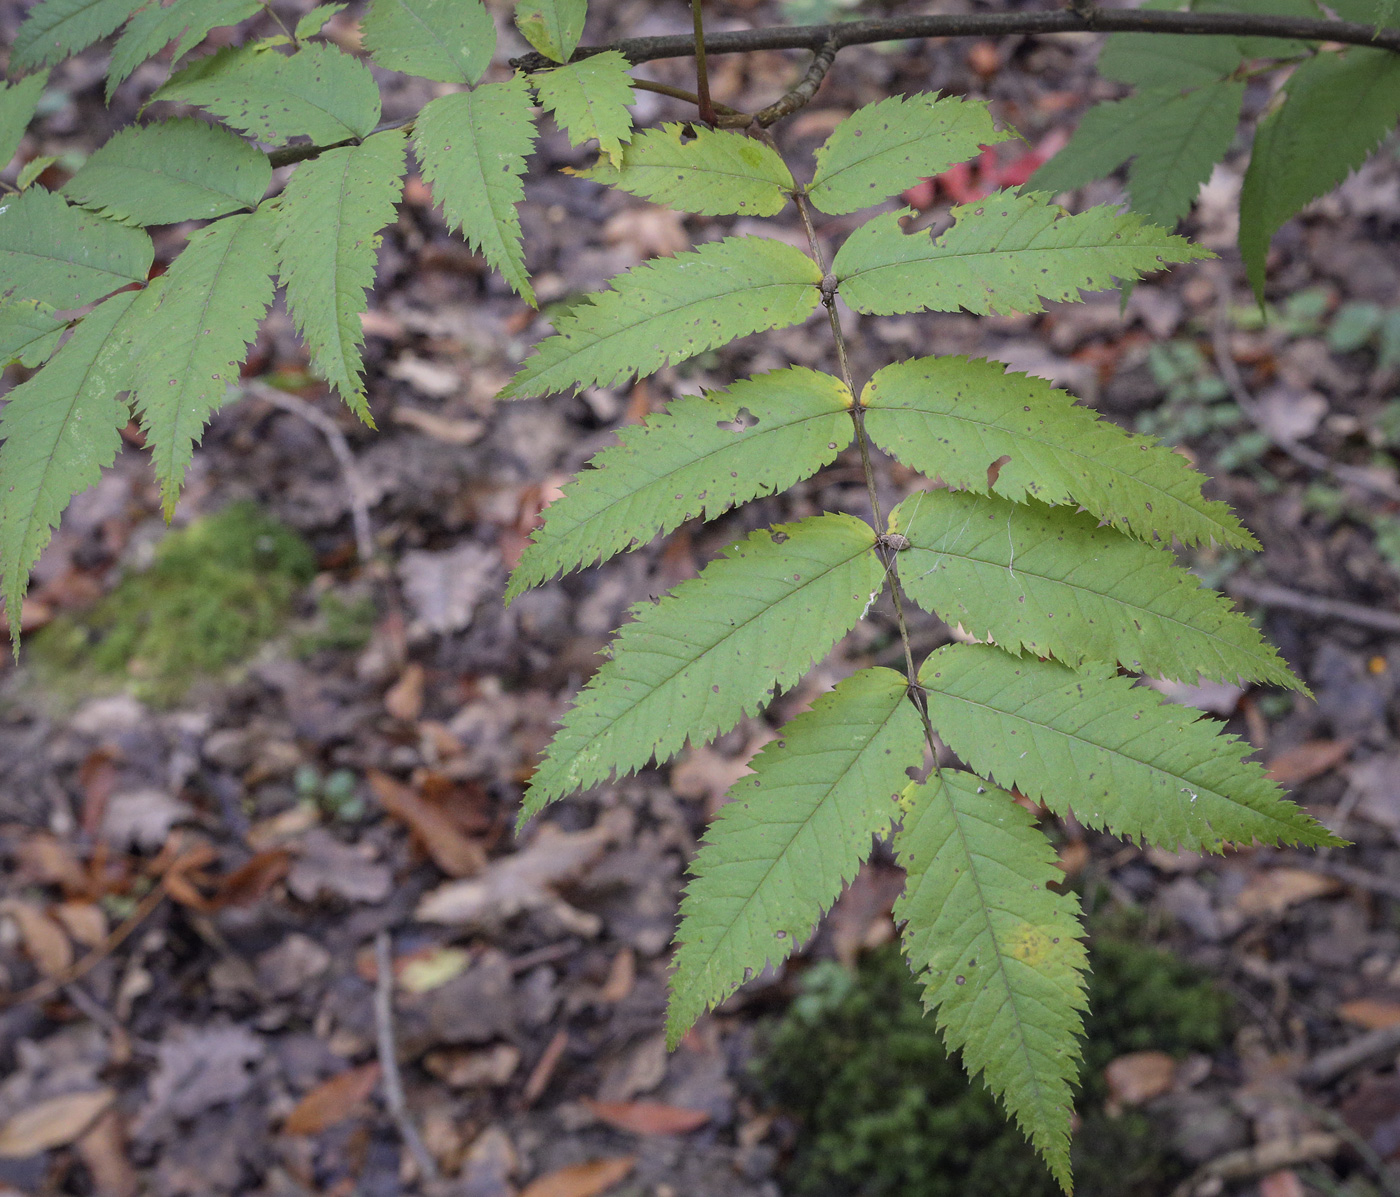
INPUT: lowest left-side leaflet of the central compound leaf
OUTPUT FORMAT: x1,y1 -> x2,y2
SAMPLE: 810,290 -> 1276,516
666,669 -> 924,1047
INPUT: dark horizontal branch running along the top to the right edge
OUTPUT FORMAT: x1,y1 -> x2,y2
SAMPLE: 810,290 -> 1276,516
511,8 -> 1400,71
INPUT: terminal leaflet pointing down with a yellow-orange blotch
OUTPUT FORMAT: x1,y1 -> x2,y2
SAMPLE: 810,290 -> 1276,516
895,769 -> 1088,1193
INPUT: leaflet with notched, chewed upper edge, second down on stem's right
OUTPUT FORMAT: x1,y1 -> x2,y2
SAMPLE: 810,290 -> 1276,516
832,192 -> 1214,316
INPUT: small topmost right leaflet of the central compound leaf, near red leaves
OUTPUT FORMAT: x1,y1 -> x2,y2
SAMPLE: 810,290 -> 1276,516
808,92 -> 1012,216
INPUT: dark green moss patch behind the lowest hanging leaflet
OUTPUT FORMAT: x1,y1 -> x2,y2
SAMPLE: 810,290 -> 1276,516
755,939 -> 1229,1197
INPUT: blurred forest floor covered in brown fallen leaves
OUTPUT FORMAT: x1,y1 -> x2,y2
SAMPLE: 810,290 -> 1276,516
0,0 -> 1400,1197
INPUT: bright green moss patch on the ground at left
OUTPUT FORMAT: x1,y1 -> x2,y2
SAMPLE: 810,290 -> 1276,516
29,503 -> 316,703
